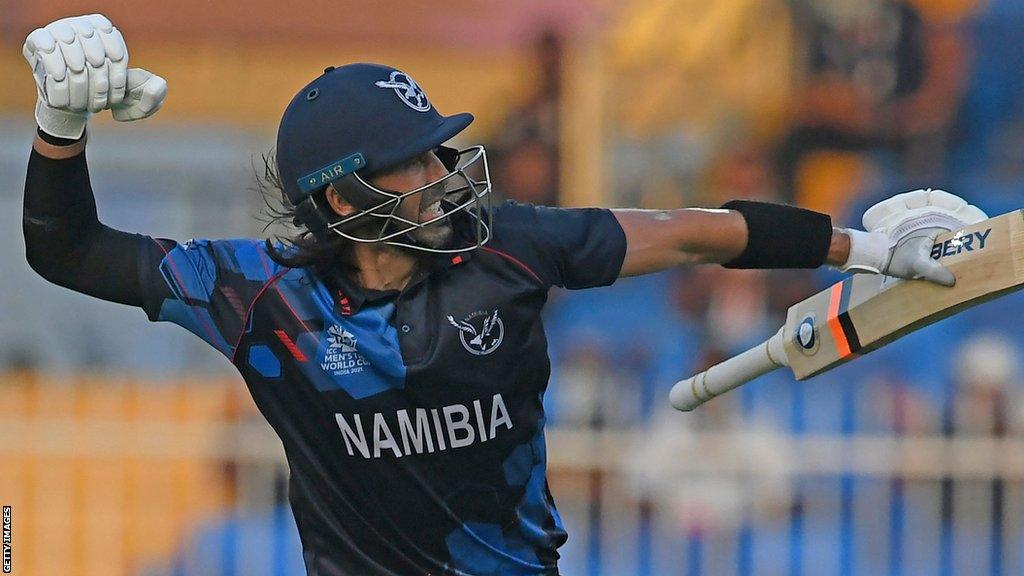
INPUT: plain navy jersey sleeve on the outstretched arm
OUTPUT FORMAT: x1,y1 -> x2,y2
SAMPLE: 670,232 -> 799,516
492,201 -> 626,289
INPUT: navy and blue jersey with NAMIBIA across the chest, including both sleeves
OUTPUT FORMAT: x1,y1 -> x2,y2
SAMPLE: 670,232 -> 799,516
141,203 -> 626,576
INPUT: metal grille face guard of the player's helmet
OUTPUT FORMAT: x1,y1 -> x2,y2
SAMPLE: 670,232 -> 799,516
308,146 -> 490,254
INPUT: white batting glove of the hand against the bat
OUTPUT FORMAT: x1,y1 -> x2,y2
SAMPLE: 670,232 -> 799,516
840,189 -> 988,286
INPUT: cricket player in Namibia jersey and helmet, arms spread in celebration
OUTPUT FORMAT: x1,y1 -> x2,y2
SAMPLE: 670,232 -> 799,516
24,14 -> 983,576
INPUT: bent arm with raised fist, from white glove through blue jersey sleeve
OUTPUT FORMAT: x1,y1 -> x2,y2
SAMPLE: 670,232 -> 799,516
23,14 -> 288,358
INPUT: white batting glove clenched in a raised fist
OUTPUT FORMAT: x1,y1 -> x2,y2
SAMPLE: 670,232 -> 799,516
22,14 -> 167,139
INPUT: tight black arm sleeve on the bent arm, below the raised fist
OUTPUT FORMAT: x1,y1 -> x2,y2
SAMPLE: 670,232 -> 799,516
23,129 -> 174,306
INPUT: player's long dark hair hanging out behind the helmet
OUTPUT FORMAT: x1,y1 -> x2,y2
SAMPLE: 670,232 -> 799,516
252,152 -> 355,272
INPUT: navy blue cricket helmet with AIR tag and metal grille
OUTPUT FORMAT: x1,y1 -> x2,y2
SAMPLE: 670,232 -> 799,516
276,64 -> 490,252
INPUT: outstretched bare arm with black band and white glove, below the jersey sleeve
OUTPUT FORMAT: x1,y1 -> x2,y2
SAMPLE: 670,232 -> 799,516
613,190 -> 985,286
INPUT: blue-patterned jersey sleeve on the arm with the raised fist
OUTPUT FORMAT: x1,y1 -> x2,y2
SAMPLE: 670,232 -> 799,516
139,239 -> 276,358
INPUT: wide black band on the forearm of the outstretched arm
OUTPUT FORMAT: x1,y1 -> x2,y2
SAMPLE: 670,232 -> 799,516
722,200 -> 833,269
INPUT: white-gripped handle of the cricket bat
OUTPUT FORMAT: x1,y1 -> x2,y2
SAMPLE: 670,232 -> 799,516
669,327 -> 790,412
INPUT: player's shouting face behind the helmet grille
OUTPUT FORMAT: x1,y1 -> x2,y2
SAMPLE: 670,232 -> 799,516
370,151 -> 452,248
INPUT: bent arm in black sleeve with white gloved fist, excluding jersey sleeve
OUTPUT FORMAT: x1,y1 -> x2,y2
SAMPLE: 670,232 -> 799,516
23,14 -> 167,305
